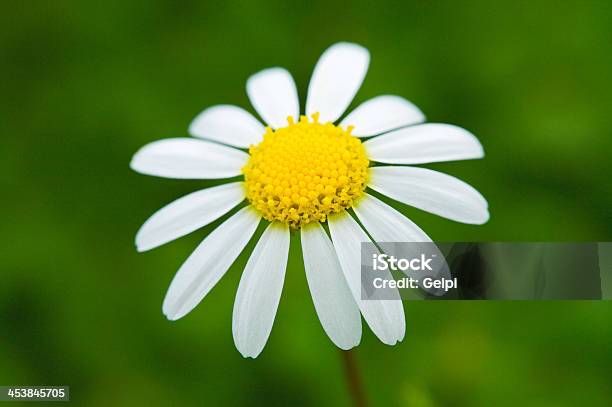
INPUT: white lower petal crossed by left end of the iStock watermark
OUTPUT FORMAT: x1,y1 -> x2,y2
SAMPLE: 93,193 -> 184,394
329,211 -> 406,345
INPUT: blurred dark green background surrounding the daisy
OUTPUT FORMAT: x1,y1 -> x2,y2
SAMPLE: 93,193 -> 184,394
0,0 -> 612,406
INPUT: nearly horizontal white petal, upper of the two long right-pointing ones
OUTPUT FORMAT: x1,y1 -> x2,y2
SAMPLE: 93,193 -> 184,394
363,123 -> 484,164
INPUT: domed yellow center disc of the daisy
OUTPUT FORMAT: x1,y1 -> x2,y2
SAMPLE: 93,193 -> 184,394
242,114 -> 369,229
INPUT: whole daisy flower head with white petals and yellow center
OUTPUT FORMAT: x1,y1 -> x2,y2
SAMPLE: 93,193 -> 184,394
131,43 -> 489,358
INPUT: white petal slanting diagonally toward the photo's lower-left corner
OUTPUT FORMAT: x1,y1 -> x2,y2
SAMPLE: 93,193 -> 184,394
162,206 -> 261,320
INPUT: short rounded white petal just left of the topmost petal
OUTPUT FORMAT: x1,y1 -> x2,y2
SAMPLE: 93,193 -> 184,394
247,68 -> 300,129
